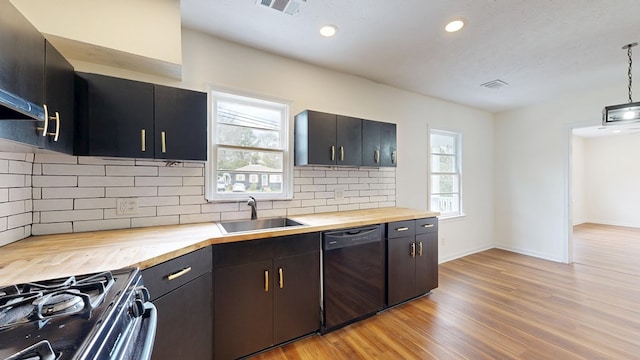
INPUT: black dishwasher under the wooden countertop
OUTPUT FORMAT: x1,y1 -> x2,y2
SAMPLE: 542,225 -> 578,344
321,225 -> 384,333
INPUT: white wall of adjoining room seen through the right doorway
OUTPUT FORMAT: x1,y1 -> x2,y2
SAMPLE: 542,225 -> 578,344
584,134 -> 640,227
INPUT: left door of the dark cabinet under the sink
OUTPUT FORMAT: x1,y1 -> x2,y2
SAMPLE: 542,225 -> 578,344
214,260 -> 275,360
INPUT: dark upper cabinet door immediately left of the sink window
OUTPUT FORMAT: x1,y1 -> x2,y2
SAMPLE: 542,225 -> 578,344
154,85 -> 207,160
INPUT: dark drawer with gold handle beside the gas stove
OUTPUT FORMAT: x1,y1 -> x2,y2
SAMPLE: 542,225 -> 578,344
142,246 -> 213,300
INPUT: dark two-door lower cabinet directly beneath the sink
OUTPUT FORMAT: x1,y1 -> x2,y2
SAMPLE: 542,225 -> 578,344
214,233 -> 320,360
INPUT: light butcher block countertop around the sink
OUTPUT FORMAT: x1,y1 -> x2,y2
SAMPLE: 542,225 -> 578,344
0,207 -> 439,287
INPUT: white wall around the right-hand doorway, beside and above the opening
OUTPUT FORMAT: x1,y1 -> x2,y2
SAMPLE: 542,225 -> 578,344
494,87 -> 626,262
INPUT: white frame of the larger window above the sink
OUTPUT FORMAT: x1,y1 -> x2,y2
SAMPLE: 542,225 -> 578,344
205,86 -> 294,202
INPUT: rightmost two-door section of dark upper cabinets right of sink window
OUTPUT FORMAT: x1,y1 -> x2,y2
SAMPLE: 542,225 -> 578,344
362,120 -> 397,167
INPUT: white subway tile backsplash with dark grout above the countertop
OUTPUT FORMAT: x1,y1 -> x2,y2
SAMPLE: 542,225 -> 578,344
0,153 -> 396,242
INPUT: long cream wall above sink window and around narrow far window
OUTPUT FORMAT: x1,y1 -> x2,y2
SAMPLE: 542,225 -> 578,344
182,29 -> 493,260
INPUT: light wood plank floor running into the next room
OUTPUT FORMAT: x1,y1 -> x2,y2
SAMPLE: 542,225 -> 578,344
252,225 -> 640,360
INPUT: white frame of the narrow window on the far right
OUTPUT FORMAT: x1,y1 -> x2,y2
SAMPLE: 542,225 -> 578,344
427,128 -> 464,218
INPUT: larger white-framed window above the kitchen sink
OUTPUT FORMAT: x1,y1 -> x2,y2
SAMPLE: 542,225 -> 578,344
207,91 -> 292,200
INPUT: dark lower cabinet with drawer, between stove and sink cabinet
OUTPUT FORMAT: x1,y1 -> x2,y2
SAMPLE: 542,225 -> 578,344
142,247 -> 213,360
